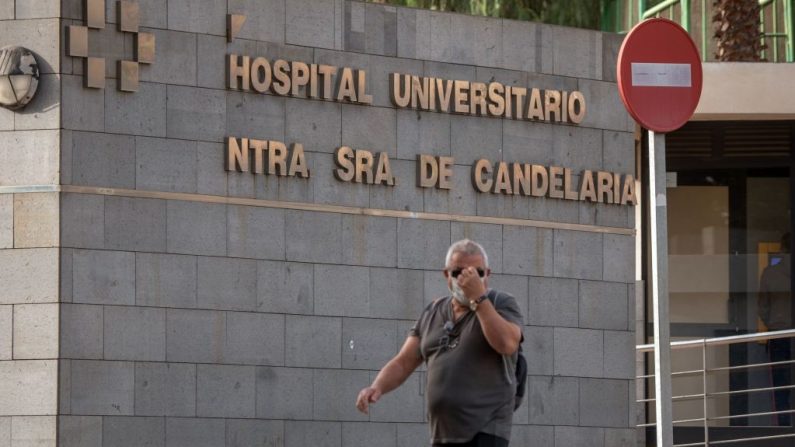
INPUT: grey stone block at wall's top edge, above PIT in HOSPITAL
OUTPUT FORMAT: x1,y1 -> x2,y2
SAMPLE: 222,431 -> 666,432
285,0 -> 342,48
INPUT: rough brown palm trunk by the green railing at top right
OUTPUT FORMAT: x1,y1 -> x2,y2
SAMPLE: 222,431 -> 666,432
712,0 -> 765,62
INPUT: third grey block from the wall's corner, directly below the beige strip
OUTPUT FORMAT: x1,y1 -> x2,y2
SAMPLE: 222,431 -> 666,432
166,201 -> 226,256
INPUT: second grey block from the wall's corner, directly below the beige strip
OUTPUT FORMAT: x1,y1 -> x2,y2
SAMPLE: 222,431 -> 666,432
105,197 -> 166,252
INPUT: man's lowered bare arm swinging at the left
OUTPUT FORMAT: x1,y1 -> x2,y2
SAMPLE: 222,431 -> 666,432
356,335 -> 422,414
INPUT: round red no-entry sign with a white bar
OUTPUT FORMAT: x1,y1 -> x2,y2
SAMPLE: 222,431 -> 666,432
616,19 -> 702,132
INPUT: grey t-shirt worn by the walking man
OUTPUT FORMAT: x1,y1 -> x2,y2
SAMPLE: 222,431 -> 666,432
409,290 -> 522,443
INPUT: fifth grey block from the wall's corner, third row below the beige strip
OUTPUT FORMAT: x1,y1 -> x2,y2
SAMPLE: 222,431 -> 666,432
285,315 -> 342,368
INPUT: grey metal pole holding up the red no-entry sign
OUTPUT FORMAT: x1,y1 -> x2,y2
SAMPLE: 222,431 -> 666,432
648,130 -> 673,447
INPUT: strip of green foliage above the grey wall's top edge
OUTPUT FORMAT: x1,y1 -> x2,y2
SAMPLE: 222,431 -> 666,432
368,0 -> 612,29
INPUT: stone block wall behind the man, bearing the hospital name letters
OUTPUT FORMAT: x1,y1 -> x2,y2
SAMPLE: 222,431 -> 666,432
0,0 -> 635,447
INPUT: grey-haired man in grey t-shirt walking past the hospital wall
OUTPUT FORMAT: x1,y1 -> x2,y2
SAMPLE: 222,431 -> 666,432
356,239 -> 522,447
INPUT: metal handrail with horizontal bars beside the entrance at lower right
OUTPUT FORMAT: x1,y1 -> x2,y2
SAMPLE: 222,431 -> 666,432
636,329 -> 795,447
